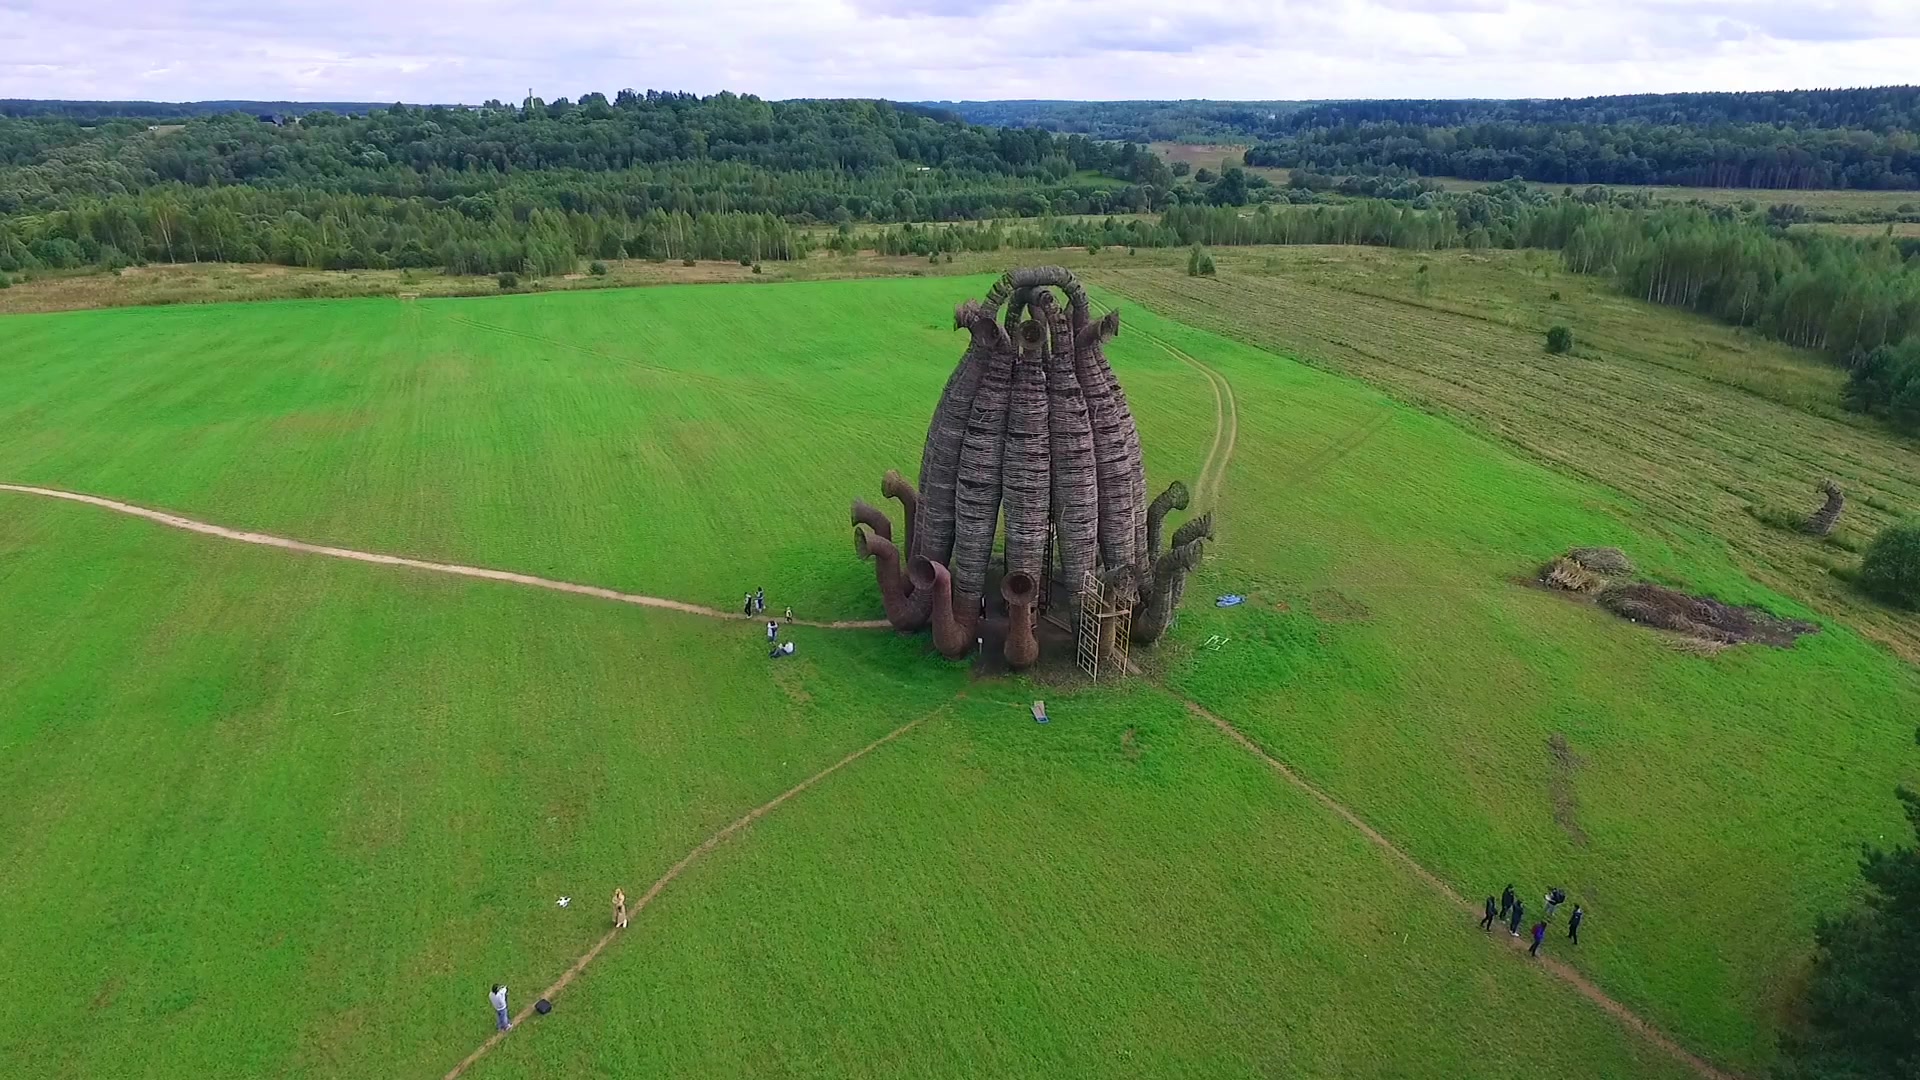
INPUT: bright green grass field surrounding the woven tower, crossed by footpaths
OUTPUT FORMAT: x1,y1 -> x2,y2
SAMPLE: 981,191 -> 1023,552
0,272 -> 1920,1076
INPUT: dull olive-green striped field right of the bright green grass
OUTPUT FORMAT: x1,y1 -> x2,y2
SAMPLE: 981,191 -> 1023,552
1083,248 -> 1920,661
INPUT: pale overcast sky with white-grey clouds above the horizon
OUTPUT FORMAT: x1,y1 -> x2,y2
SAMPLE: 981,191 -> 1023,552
0,0 -> 1920,104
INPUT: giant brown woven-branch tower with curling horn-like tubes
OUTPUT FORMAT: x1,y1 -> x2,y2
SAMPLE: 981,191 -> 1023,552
852,267 -> 1213,669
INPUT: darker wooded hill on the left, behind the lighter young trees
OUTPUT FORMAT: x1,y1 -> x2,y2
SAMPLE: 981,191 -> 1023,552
0,90 -> 1137,190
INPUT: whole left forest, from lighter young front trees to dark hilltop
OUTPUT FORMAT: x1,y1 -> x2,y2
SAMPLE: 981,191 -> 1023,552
0,90 -> 1181,273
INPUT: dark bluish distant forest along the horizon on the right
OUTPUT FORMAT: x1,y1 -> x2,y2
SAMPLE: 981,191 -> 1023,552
935,86 -> 1920,188
